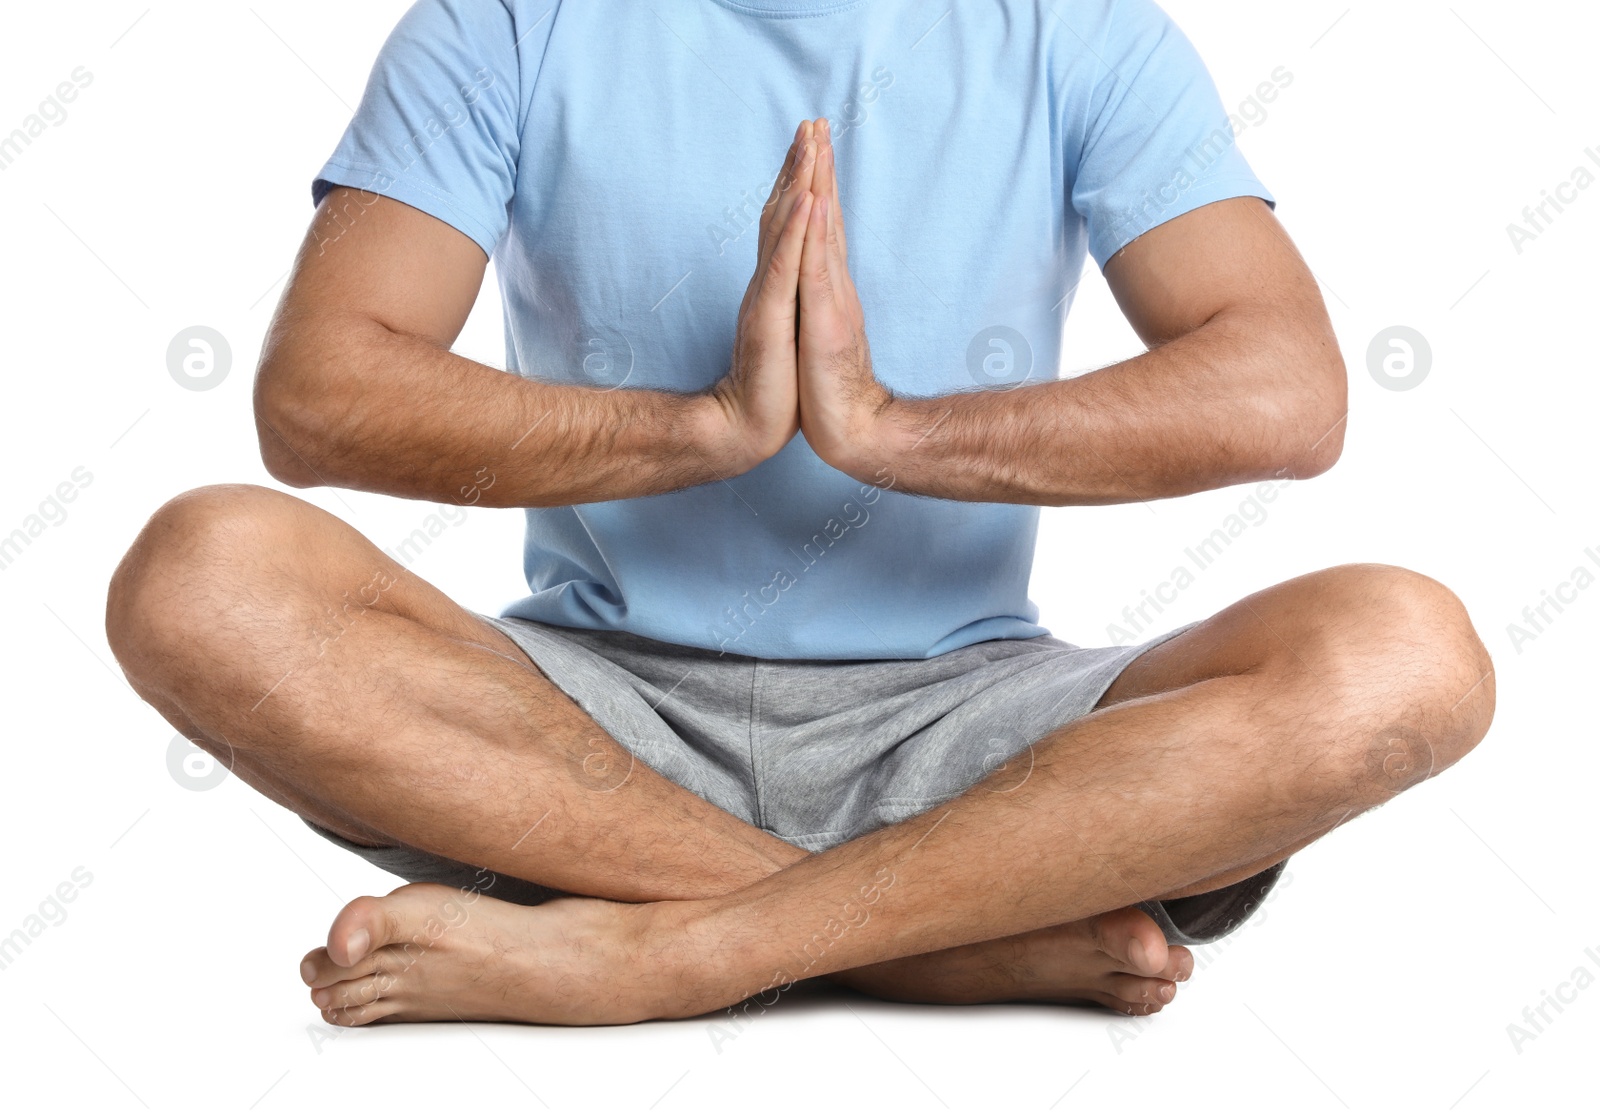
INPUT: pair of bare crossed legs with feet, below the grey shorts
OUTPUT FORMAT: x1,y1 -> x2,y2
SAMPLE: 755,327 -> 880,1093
107,487 -> 1493,1023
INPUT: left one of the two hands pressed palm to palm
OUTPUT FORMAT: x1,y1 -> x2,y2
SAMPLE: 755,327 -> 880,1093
710,120 -> 818,474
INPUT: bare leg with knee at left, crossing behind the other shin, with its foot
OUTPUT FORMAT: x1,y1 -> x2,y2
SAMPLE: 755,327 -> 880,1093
107,487 -> 1192,1009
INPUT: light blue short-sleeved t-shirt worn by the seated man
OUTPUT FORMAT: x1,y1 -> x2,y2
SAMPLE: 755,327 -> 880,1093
312,0 -> 1272,660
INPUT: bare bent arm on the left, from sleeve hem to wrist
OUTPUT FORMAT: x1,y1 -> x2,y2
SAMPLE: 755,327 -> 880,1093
254,187 -> 792,506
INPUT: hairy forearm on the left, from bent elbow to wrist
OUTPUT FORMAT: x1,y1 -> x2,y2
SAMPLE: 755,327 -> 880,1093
256,320 -> 744,507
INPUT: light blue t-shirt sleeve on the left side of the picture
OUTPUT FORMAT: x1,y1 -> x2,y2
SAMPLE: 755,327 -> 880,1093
312,0 -> 520,256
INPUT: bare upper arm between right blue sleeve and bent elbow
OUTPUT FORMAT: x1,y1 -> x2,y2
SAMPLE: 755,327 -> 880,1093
1106,197 -> 1333,347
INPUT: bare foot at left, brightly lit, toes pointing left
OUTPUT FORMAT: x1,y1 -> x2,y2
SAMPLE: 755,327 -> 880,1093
301,884 -> 681,1026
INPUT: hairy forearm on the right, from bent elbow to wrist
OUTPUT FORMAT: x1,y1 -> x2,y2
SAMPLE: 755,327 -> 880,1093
846,317 -> 1346,506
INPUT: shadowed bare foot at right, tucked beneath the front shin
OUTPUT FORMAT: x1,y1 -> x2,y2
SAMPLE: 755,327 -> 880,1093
834,908 -> 1194,1015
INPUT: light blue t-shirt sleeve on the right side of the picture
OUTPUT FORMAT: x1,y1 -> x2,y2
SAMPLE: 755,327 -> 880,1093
1066,0 -> 1275,269
